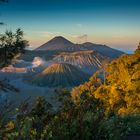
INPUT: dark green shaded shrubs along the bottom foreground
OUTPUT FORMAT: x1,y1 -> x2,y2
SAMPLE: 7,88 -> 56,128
1,96 -> 140,140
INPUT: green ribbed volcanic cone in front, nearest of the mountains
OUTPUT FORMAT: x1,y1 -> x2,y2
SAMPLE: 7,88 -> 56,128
31,63 -> 89,87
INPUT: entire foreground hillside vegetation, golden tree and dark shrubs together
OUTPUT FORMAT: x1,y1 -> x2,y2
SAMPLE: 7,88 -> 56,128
0,47 -> 140,140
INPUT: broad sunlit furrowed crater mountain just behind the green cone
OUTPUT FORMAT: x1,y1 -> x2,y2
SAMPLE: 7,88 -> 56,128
53,51 -> 109,74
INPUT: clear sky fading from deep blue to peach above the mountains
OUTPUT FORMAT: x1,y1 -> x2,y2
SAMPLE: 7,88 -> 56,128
0,0 -> 140,53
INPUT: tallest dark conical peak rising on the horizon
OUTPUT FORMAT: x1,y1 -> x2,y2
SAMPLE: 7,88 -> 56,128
36,36 -> 74,50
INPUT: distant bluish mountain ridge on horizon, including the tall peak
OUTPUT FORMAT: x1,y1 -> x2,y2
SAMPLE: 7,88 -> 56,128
35,36 -> 124,58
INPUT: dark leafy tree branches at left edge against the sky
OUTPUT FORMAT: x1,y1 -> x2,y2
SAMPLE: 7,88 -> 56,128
0,29 -> 28,66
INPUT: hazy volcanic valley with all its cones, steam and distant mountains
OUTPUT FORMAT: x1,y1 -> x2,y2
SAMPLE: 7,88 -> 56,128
0,36 -> 123,106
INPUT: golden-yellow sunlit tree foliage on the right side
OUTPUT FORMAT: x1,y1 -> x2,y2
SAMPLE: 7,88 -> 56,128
72,44 -> 140,115
